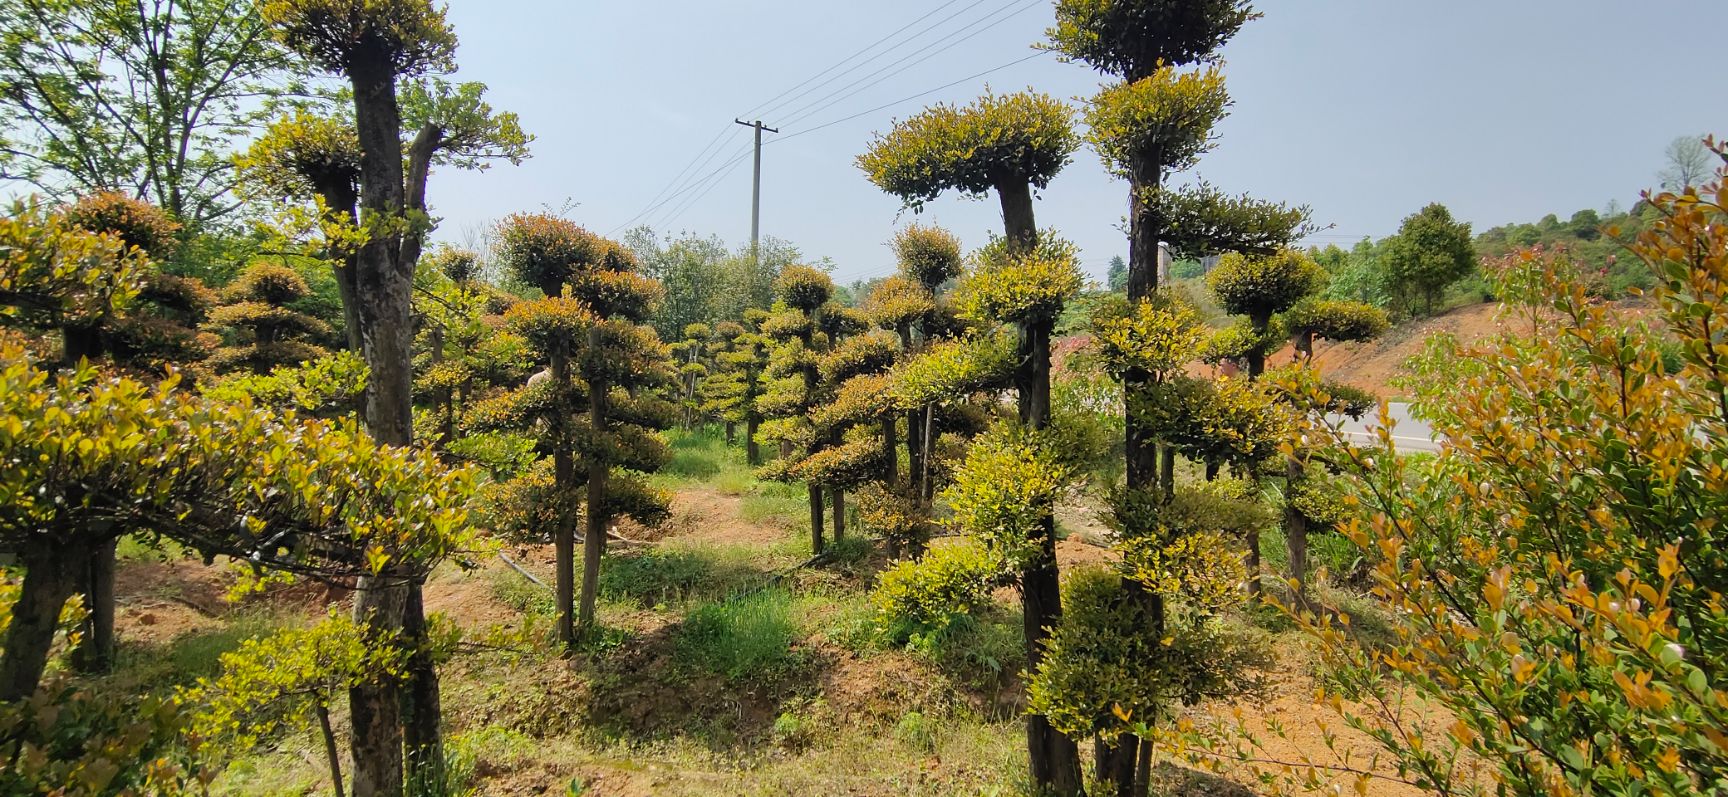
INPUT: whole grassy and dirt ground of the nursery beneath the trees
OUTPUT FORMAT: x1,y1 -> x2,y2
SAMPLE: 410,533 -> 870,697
92,429 -> 1419,797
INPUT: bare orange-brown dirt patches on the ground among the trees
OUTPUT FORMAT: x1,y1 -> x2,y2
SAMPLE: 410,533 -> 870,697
118,470 -> 1444,797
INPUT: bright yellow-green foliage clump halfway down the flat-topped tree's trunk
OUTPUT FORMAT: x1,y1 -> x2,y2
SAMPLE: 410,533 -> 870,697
942,425 -> 1077,569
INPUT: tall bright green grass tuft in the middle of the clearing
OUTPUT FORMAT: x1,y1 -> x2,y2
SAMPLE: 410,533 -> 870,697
677,590 -> 798,679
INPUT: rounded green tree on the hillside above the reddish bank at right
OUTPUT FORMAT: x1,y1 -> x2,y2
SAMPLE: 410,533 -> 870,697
1381,202 -> 1476,315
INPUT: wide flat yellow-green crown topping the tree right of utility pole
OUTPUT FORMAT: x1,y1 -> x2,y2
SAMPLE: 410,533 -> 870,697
857,92 -> 1080,209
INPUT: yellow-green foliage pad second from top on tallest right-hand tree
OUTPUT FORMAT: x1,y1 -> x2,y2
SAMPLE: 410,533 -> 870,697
1085,66 -> 1230,178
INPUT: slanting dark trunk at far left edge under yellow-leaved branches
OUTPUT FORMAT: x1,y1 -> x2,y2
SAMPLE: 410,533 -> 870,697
0,546 -> 90,702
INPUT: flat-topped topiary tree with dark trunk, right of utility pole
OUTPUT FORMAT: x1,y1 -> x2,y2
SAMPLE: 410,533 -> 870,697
859,85 -> 1082,794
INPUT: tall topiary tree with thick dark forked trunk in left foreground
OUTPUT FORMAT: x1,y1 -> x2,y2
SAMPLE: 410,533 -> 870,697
259,0 -> 527,777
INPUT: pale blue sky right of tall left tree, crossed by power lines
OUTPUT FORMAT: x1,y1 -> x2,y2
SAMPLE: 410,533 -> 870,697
429,0 -> 1728,284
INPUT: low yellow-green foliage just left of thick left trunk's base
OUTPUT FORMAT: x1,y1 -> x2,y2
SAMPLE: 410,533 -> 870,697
178,610 -> 408,750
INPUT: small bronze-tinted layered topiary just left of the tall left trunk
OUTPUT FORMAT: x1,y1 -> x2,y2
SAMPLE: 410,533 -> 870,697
209,263 -> 330,373
